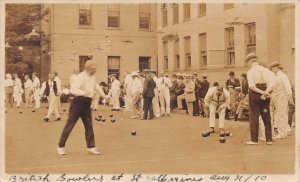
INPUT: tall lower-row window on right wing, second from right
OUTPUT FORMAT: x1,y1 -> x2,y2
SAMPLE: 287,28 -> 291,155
225,27 -> 235,66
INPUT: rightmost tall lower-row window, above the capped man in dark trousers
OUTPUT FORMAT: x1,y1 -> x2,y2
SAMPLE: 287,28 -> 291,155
245,23 -> 256,54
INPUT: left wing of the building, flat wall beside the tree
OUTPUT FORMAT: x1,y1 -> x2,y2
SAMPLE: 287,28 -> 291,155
42,4 -> 157,85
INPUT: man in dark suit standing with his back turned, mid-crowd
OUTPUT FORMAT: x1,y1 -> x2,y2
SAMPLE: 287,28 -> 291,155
142,71 -> 156,120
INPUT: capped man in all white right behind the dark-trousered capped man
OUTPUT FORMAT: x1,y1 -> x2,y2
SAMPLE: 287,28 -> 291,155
270,62 -> 294,139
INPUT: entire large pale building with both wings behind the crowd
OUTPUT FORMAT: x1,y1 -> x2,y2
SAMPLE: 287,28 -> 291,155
42,3 -> 295,84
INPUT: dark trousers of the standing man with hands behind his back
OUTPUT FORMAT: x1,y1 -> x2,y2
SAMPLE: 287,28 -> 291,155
249,86 -> 272,142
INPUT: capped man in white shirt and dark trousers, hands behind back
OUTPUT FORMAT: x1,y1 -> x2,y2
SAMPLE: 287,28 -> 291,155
246,53 -> 276,145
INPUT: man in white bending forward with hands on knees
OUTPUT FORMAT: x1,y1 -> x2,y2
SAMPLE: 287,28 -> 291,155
204,82 -> 230,135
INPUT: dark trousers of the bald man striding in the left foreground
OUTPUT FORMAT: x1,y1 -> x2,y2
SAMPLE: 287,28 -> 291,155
58,96 -> 95,148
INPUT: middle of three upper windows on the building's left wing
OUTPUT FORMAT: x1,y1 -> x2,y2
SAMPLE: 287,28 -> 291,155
107,4 -> 120,28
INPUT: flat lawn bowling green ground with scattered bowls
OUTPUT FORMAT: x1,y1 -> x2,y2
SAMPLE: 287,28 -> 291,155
5,104 -> 295,174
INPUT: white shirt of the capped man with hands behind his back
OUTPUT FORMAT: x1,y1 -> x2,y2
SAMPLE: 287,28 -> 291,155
247,63 -> 276,88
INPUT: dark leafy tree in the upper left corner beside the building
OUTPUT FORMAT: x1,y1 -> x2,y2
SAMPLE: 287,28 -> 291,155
5,4 -> 50,77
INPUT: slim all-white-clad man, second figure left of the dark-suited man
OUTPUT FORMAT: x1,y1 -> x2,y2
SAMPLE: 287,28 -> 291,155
124,72 -> 133,111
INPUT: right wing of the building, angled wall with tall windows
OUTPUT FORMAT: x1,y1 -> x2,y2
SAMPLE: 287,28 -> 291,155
157,3 -> 295,83
